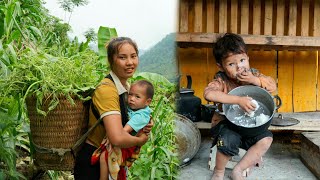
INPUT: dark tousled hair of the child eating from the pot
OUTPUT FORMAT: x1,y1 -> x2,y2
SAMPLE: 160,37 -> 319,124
213,33 -> 247,65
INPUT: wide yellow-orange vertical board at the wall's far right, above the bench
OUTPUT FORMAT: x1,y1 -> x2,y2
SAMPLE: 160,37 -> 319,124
293,51 -> 318,112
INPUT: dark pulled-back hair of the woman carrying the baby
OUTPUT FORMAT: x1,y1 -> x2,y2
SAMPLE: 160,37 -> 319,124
106,37 -> 139,69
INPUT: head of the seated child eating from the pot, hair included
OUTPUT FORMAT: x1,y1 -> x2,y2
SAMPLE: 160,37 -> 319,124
213,33 -> 250,79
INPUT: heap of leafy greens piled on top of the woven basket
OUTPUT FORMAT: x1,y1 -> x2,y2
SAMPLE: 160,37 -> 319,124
0,49 -> 101,115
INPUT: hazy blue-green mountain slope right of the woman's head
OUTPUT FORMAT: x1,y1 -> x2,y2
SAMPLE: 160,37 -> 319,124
138,33 -> 178,82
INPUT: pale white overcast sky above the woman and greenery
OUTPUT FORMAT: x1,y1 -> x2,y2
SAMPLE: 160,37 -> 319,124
45,0 -> 178,50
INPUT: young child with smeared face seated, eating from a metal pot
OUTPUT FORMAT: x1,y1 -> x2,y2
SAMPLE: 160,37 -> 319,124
204,33 -> 276,180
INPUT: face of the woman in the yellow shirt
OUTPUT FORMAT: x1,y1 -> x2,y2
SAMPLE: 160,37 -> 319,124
112,43 -> 139,83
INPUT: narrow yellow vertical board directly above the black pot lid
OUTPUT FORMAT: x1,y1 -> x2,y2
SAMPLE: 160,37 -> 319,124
278,51 -> 295,112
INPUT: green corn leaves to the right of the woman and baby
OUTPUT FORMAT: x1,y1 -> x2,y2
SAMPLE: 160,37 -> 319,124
129,73 -> 178,180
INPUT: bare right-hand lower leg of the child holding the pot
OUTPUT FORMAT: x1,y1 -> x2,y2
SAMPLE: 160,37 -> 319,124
232,137 -> 272,180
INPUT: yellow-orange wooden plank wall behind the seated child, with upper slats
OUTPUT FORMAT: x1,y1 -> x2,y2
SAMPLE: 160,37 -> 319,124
177,0 -> 320,112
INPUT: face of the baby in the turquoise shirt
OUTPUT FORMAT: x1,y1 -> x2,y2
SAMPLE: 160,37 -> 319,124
128,84 -> 151,110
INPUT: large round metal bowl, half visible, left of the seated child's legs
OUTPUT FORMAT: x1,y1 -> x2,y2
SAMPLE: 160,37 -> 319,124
175,114 -> 201,166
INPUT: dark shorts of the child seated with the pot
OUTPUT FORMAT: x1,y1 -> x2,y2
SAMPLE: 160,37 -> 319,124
211,120 -> 273,156
